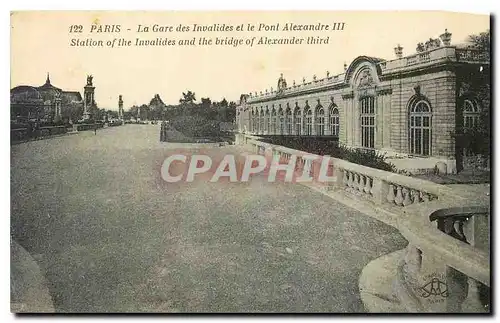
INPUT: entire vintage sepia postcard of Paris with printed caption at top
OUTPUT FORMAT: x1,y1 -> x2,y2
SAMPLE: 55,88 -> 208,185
10,11 -> 493,314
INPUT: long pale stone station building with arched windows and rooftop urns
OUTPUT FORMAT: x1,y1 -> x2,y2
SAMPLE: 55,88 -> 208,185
236,42 -> 490,172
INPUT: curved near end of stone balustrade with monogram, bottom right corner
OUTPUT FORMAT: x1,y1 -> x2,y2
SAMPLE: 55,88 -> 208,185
395,201 -> 490,313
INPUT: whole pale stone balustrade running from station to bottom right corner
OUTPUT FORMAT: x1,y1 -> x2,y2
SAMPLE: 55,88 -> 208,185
236,134 -> 490,312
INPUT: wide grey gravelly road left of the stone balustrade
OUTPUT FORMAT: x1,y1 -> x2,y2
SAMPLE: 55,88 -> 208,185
11,125 -> 405,312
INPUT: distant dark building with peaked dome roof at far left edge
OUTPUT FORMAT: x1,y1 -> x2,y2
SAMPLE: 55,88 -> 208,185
10,74 -> 95,122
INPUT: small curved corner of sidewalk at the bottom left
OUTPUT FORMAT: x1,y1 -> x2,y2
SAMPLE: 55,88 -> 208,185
10,240 -> 55,313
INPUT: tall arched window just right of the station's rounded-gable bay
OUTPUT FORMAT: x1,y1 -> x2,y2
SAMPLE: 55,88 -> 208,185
408,100 -> 432,156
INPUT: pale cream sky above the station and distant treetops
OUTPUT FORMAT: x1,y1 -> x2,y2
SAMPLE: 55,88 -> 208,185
11,11 -> 490,110
